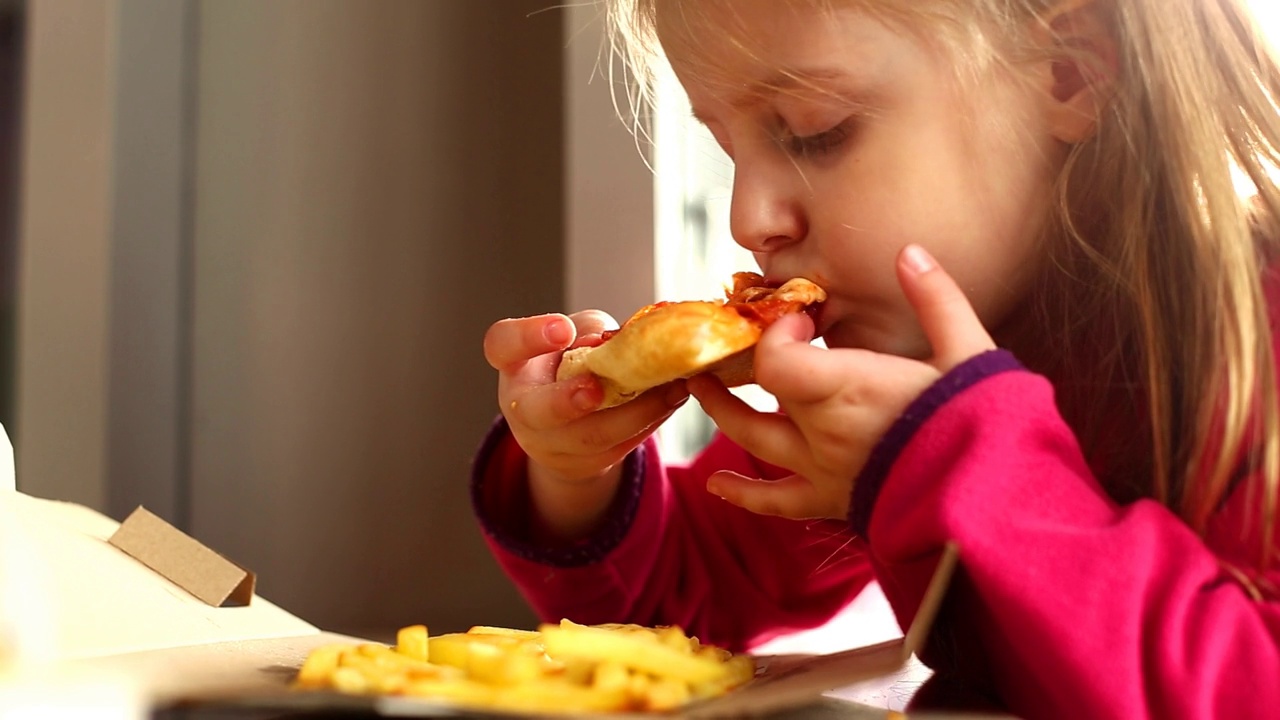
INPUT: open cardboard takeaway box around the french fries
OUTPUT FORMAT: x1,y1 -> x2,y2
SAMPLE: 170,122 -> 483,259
0,491 -> 955,717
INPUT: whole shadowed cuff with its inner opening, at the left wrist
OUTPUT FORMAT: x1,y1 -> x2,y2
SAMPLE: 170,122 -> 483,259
471,416 -> 650,568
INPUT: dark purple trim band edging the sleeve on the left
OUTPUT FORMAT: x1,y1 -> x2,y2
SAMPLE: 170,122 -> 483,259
471,416 -> 649,568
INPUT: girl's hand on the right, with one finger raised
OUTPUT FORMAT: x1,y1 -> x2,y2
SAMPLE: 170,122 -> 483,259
687,245 -> 995,520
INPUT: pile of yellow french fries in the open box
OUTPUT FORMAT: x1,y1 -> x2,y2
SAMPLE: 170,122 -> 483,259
294,620 -> 755,714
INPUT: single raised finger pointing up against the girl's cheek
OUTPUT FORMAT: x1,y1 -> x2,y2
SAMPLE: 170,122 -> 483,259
897,245 -> 996,372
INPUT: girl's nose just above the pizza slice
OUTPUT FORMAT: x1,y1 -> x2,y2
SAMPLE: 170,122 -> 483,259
730,163 -> 808,252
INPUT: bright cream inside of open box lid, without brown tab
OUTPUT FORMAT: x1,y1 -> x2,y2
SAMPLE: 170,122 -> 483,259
0,417 -> 319,670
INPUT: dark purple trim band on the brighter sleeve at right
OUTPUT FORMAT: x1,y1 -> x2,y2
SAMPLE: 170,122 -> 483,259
849,350 -> 1023,538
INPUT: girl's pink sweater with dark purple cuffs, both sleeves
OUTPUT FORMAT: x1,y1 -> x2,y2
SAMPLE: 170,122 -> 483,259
472,351 -> 1280,719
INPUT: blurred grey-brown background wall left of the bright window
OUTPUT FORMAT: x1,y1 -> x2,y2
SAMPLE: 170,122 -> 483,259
0,0 -> 652,633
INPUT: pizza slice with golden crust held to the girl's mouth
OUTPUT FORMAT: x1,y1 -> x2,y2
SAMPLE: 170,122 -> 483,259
556,273 -> 827,409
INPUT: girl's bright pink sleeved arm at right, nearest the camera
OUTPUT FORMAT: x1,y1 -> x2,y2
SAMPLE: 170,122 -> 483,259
851,352 -> 1280,719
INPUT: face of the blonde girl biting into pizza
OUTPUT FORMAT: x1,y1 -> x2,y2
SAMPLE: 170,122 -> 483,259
658,0 -> 1064,357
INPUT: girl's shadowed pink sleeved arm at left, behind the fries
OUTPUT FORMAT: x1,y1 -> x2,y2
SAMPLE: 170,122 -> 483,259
472,421 -> 872,651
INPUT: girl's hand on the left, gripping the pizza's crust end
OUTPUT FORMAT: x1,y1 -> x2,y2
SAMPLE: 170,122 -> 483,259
484,310 -> 689,536
